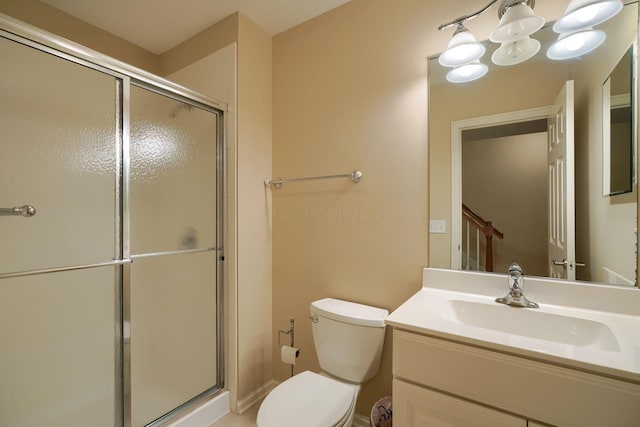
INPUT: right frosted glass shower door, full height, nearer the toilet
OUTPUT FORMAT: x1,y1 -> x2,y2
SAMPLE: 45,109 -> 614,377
125,86 -> 220,427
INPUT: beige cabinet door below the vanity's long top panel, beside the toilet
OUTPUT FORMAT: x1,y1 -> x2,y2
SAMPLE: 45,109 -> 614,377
393,380 -> 527,427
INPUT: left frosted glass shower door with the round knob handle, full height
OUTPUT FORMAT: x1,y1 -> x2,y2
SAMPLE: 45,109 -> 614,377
0,37 -> 122,427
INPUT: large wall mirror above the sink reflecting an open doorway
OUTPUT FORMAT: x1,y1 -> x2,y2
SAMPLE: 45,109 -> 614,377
428,2 -> 638,286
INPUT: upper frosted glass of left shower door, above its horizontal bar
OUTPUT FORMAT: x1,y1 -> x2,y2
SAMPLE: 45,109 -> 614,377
0,38 -> 120,273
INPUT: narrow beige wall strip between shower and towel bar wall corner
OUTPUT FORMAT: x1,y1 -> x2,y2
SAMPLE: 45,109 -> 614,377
238,15 -> 273,410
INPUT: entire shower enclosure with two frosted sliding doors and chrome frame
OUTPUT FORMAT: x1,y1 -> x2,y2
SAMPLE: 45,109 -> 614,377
0,16 -> 226,427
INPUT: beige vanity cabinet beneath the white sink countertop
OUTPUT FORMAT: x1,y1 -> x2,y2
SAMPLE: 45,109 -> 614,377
393,328 -> 640,427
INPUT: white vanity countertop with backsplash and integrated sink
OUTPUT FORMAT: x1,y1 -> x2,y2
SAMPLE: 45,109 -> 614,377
386,269 -> 640,383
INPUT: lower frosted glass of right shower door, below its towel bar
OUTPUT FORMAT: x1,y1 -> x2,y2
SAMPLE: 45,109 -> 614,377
131,251 -> 217,427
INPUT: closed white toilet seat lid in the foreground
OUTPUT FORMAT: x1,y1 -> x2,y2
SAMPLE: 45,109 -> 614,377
257,371 -> 355,427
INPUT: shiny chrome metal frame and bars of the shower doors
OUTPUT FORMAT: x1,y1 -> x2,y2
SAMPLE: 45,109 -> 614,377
0,13 -> 228,427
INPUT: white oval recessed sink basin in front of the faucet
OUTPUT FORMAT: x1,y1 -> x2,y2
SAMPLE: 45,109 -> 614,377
442,299 -> 620,351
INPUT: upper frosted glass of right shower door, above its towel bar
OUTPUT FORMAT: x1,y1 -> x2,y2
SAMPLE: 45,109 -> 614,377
130,86 -> 217,254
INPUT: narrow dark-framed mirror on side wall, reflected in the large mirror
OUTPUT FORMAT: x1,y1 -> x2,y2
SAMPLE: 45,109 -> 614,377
602,45 -> 636,196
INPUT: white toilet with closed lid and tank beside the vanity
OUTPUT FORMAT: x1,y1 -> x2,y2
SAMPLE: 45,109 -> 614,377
257,298 -> 389,427
